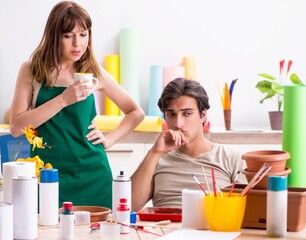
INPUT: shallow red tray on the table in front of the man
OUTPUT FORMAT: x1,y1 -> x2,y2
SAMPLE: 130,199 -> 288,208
137,207 -> 182,222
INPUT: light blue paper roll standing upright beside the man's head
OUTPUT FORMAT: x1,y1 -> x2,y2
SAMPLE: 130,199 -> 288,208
148,65 -> 163,116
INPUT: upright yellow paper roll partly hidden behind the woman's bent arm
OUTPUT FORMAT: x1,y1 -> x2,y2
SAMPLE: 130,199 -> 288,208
104,55 -> 120,116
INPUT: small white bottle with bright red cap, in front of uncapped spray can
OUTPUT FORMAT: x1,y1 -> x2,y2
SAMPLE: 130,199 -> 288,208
117,198 -> 130,234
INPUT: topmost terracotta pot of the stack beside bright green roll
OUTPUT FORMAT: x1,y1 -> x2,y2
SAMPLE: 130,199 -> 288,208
241,150 -> 290,172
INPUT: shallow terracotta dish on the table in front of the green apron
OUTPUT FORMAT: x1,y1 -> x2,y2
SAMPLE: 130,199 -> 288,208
59,206 -> 112,222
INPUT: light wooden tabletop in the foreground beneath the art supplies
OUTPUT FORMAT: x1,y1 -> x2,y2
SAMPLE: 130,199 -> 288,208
38,222 -> 306,240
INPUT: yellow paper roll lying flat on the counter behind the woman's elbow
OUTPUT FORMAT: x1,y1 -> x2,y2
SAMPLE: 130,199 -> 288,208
94,115 -> 162,132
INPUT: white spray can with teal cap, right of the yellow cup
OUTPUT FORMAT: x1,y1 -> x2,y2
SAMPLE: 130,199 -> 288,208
267,176 -> 288,238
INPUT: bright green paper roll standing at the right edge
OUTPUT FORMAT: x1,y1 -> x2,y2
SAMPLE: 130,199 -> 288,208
283,86 -> 306,187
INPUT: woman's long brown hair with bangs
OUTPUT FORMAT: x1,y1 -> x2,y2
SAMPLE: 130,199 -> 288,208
31,1 -> 102,86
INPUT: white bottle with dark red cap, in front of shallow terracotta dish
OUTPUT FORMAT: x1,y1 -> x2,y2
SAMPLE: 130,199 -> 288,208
60,202 -> 74,240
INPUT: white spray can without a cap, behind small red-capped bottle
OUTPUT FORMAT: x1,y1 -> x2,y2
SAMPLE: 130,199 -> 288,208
112,171 -> 131,221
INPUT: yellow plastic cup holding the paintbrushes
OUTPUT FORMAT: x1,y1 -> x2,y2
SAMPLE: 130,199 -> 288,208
205,192 -> 247,232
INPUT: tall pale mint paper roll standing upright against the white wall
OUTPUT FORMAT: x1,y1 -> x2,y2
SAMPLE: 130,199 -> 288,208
119,28 -> 141,105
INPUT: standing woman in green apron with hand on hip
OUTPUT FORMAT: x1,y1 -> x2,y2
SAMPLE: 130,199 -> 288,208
10,1 -> 144,208
